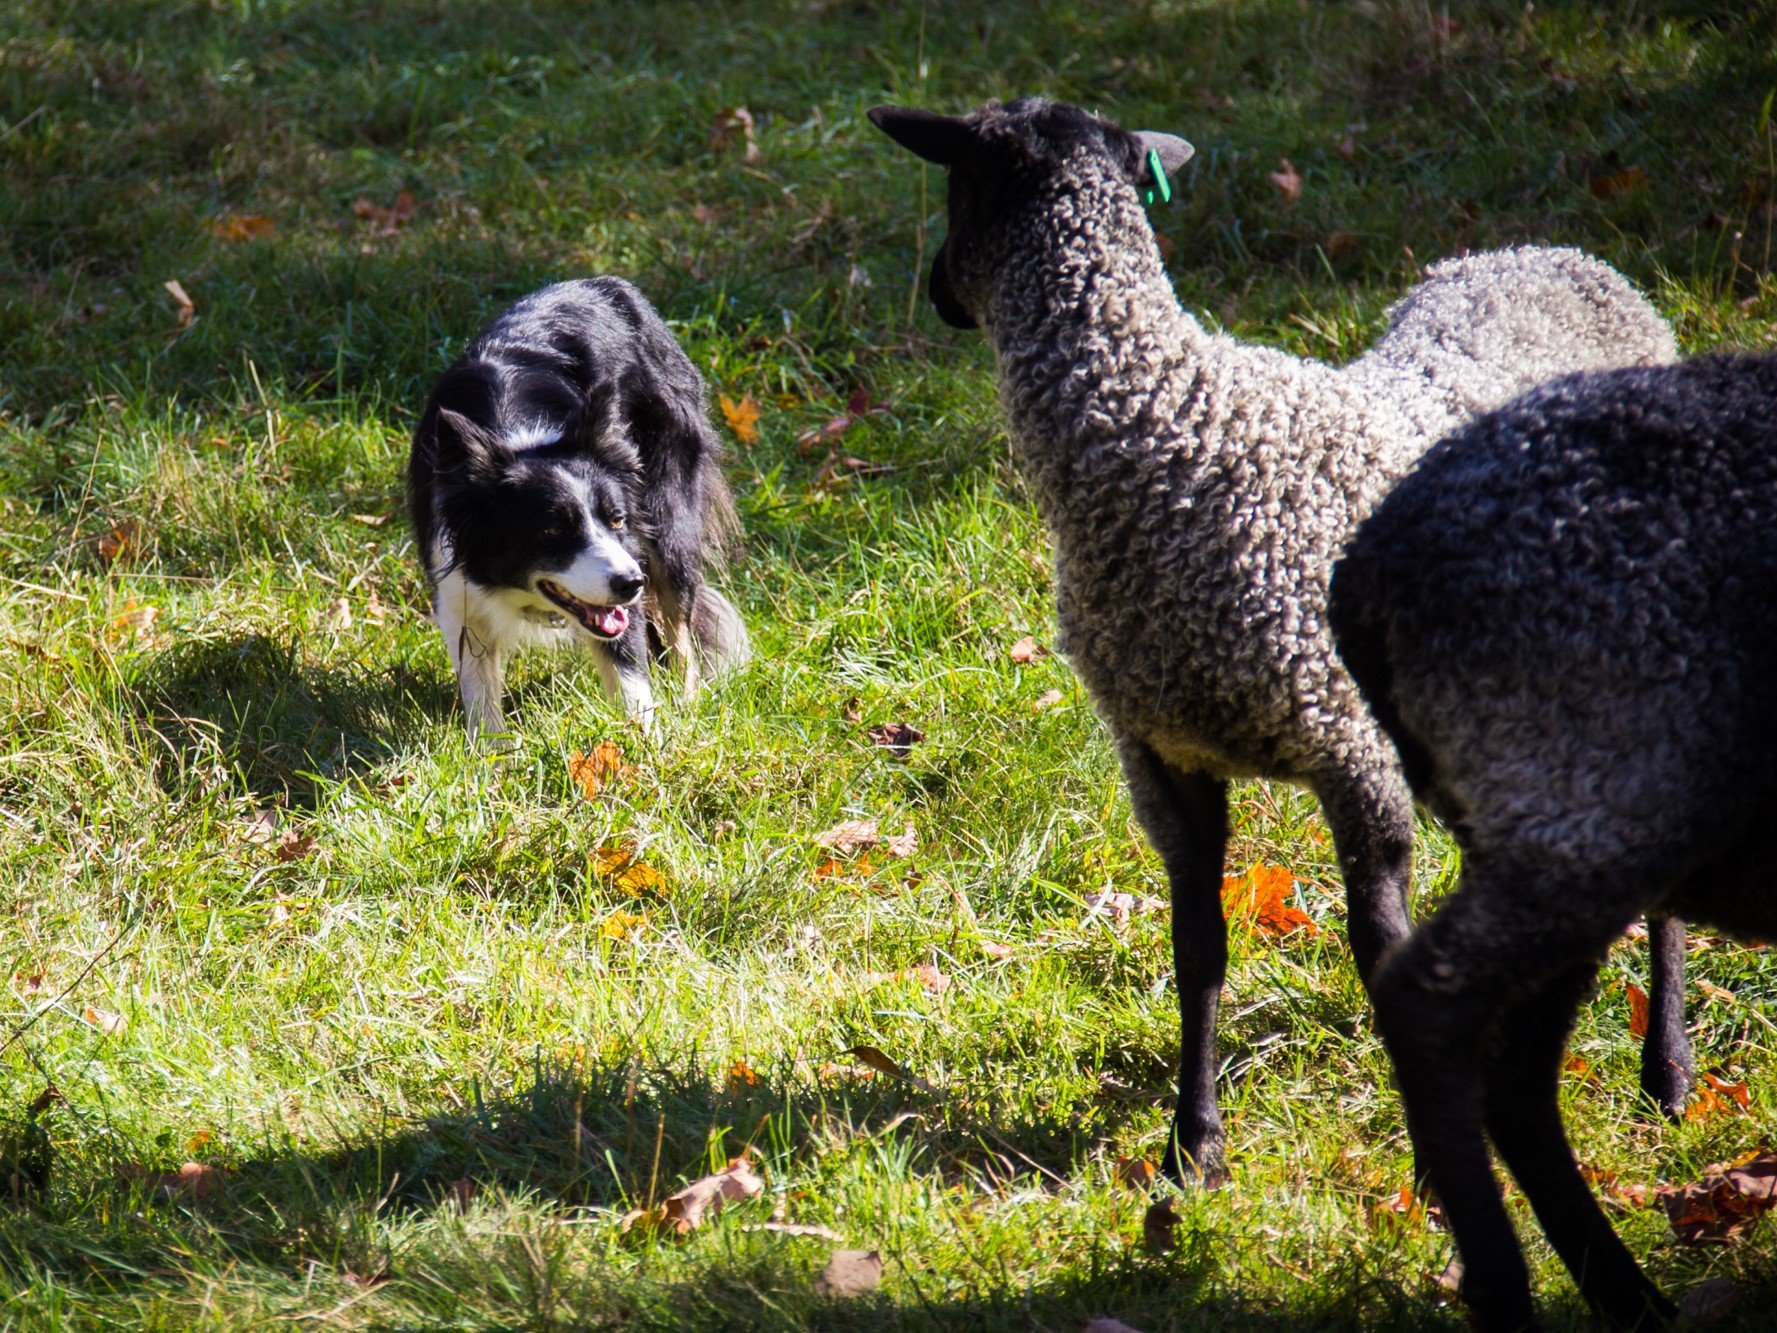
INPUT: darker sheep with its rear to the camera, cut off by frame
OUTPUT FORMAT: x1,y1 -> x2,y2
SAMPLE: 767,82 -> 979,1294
1331,355 -> 1777,1333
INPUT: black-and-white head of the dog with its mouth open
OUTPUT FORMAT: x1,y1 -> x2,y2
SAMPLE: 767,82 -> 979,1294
434,389 -> 647,640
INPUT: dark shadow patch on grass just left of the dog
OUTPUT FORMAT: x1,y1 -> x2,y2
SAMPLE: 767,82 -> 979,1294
133,635 -> 453,803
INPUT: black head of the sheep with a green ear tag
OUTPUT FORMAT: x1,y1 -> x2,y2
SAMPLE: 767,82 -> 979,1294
869,98 -> 1192,329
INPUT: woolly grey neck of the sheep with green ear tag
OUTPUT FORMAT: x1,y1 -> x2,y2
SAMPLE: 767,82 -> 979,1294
986,183 -> 1208,515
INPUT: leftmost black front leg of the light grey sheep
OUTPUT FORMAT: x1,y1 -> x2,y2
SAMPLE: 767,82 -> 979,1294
1118,736 -> 1228,1184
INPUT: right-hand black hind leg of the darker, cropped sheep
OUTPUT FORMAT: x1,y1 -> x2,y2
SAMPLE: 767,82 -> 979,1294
1484,962 -> 1677,1329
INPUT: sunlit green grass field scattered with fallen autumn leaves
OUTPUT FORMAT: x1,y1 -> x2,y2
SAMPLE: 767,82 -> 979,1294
0,0 -> 1777,1333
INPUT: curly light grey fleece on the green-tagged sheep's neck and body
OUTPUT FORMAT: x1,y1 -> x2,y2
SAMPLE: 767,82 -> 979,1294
970,138 -> 1676,803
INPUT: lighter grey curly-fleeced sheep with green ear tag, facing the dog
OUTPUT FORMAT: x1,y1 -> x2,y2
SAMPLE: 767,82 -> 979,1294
871,98 -> 1676,1178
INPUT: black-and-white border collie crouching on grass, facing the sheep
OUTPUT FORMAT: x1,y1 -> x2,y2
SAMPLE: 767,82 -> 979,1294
407,277 -> 748,736
